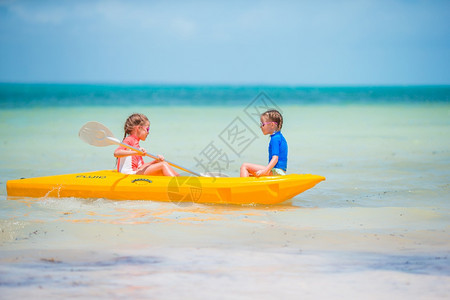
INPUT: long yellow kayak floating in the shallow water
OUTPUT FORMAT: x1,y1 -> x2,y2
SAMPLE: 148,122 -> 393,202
6,170 -> 325,204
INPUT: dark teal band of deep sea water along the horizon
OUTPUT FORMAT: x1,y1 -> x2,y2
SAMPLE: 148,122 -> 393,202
0,83 -> 450,109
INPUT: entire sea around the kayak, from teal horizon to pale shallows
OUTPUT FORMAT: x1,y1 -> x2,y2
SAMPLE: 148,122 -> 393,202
0,85 -> 450,299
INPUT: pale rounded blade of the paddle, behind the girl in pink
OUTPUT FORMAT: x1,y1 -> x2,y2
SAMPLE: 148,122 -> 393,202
78,122 -> 120,147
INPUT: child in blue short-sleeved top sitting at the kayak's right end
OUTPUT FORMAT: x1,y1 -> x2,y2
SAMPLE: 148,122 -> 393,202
241,110 -> 288,177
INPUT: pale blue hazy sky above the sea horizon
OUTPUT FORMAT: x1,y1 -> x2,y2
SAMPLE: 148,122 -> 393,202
0,0 -> 450,85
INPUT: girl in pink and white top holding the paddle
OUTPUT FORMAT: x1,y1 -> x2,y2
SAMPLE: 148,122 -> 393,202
114,114 -> 178,176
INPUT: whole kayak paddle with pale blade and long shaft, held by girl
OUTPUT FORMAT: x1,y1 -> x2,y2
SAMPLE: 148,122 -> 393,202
78,122 -> 201,176
